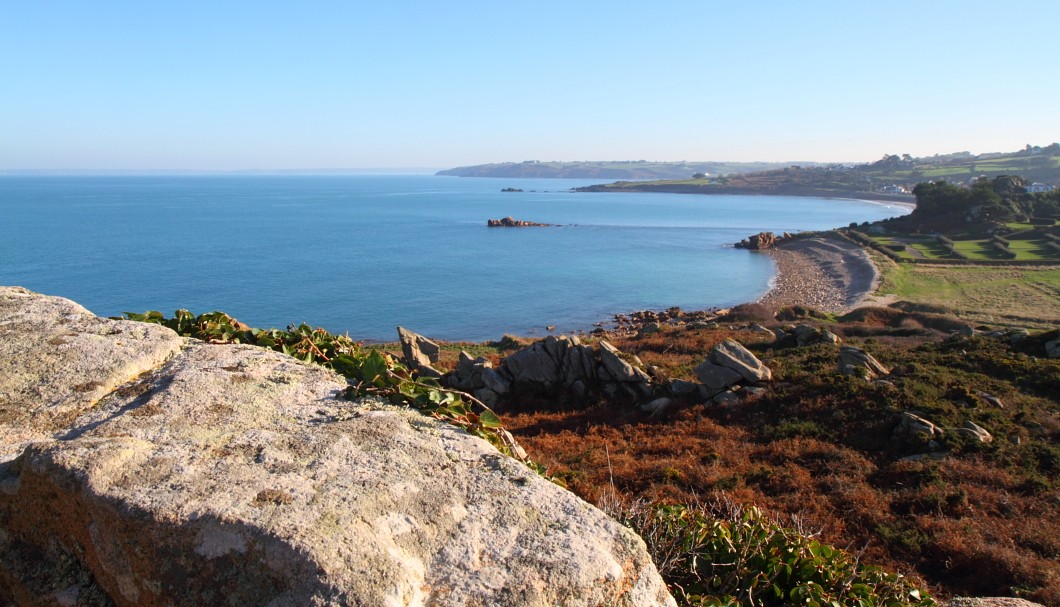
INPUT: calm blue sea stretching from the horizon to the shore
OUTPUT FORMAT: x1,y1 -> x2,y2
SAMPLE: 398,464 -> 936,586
0,176 -> 905,341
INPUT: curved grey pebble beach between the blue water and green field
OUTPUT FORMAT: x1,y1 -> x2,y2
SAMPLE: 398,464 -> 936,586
759,236 -> 880,313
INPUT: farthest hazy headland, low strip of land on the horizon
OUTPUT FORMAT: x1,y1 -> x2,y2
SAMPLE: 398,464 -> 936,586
438,160 -> 801,179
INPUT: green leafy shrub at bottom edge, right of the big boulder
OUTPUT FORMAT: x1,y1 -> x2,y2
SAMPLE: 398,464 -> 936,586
613,502 -> 936,607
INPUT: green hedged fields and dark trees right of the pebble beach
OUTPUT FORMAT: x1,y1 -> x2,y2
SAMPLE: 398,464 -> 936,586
840,175 -> 1060,328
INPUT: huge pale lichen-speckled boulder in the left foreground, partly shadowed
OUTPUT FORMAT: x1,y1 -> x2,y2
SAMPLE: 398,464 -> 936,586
0,287 -> 674,607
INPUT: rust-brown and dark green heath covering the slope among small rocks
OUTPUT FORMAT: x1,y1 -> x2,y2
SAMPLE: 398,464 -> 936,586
504,310 -> 1060,605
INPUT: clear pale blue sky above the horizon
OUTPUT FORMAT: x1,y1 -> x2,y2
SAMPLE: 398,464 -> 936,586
0,0 -> 1060,171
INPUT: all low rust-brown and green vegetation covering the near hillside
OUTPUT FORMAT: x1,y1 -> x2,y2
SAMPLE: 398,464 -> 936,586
127,305 -> 1060,605
